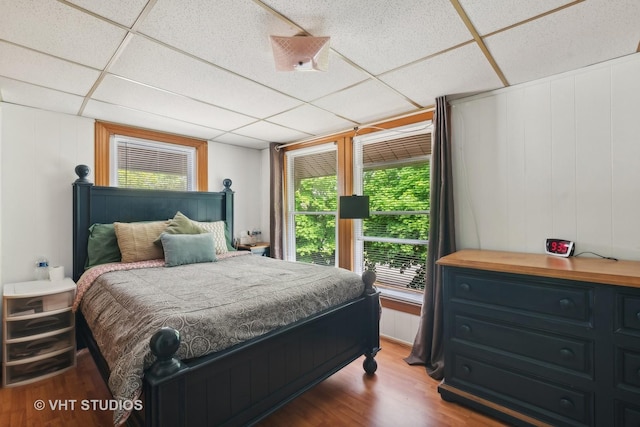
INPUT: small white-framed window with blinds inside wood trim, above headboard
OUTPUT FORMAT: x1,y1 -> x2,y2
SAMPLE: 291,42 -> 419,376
110,135 -> 196,191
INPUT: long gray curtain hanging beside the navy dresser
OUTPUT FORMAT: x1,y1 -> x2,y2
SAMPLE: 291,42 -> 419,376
405,96 -> 456,379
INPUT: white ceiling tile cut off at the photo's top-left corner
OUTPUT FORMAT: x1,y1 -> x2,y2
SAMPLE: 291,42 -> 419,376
0,0 -> 125,69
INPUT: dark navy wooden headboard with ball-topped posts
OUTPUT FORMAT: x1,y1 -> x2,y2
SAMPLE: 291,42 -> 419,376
73,165 -> 233,281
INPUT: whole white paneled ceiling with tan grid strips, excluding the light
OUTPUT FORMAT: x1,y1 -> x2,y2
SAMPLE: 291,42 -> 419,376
0,0 -> 640,149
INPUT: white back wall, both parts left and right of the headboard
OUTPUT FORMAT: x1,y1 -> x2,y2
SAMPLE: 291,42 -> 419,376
0,102 -> 268,284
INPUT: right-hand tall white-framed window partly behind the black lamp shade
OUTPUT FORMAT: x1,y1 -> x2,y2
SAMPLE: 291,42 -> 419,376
354,123 -> 431,290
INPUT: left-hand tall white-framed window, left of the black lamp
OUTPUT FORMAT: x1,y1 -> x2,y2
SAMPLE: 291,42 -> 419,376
285,144 -> 338,266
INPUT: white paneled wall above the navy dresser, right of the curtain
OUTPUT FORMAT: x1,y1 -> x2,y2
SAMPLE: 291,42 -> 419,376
451,54 -> 640,260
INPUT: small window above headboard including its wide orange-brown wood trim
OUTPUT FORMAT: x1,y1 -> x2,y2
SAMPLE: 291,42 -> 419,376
95,121 -> 209,191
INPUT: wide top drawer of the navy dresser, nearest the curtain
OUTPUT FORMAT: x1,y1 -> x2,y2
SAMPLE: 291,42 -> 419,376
450,271 -> 593,322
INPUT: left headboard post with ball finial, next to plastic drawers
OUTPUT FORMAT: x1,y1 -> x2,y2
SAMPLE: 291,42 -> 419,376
73,165 -> 93,282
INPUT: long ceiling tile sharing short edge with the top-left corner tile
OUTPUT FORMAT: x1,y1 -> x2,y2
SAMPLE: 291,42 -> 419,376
110,37 -> 301,118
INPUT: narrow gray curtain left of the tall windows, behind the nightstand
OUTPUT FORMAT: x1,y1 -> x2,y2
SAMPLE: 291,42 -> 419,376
269,143 -> 284,259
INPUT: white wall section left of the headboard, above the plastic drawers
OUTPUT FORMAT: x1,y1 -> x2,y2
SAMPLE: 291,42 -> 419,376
0,103 -> 94,284
